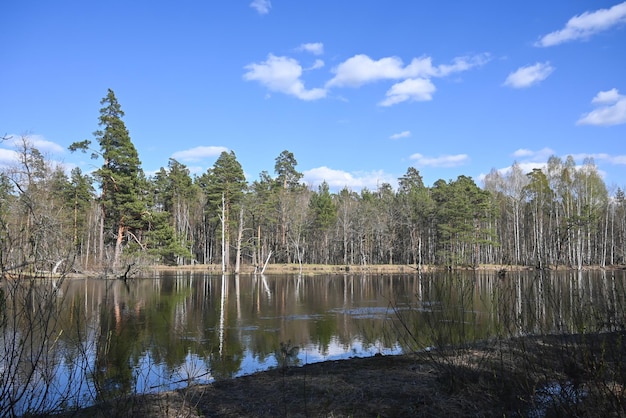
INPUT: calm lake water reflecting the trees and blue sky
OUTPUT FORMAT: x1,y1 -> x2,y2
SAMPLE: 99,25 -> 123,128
0,272 -> 626,414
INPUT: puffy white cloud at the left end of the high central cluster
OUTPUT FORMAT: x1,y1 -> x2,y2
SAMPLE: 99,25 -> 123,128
244,54 -> 326,100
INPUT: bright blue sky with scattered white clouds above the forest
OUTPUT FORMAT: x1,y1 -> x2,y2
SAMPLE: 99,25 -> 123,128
0,0 -> 626,191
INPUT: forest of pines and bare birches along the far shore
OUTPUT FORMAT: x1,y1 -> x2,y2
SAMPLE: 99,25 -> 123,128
0,89 -> 626,276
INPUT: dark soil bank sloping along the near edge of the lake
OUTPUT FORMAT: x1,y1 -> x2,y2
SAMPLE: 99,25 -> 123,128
61,332 -> 626,417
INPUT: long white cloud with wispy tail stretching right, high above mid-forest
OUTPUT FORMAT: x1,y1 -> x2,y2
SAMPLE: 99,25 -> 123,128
326,54 -> 489,87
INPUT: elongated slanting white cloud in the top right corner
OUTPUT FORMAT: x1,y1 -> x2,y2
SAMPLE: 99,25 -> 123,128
535,2 -> 626,46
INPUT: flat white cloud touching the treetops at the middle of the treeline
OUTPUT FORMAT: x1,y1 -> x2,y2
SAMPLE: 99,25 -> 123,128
302,166 -> 397,190
